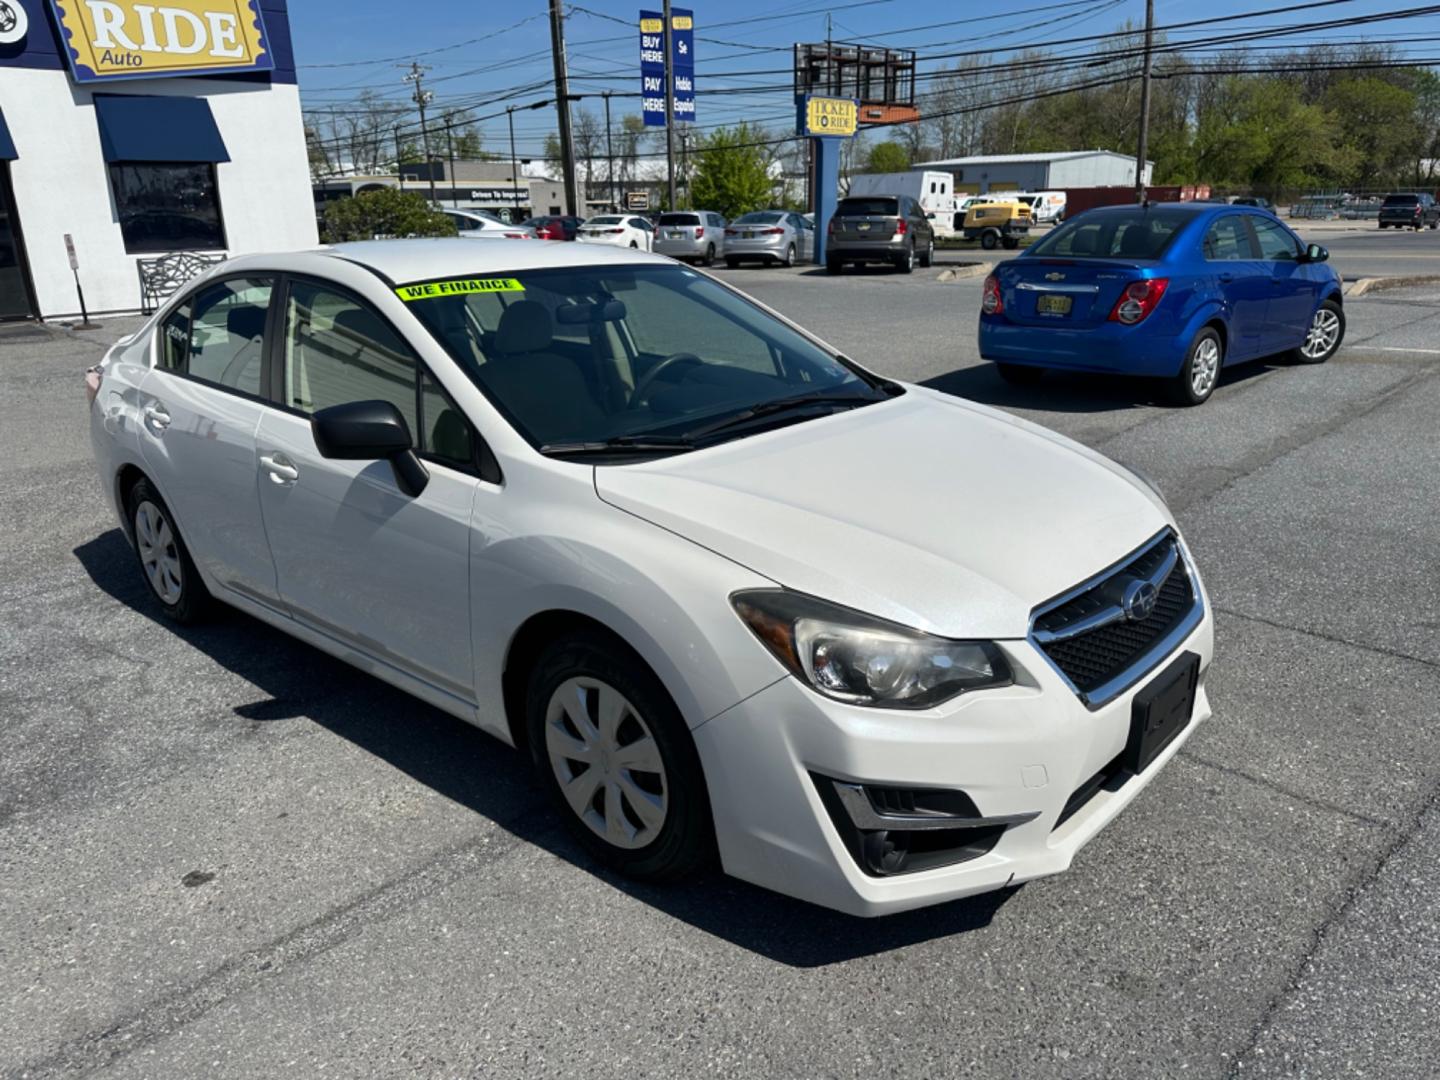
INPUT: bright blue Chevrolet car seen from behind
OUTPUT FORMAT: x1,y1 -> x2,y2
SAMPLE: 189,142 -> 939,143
979,203 -> 1345,405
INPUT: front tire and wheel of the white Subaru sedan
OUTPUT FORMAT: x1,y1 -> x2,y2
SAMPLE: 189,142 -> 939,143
526,631 -> 714,881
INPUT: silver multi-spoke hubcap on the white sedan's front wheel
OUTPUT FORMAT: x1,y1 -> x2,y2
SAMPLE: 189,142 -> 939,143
544,677 -> 668,851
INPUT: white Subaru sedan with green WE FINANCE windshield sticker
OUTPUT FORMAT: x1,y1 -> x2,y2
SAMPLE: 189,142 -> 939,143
86,240 -> 1212,914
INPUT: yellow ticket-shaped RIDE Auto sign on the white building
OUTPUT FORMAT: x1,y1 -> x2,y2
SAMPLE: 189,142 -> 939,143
50,0 -> 275,82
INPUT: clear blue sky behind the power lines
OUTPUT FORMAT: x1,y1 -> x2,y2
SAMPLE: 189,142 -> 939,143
291,0 -> 1440,157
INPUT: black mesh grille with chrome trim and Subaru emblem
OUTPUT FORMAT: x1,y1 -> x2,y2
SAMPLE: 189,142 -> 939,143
1030,530 -> 1204,708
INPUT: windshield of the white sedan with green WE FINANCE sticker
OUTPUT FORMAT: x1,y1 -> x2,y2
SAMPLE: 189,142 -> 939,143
399,265 -> 896,452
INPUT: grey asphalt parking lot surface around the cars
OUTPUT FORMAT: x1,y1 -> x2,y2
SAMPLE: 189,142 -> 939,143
0,266 -> 1440,1077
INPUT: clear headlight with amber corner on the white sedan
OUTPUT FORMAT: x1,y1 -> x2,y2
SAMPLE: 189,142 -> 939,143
730,589 -> 1012,708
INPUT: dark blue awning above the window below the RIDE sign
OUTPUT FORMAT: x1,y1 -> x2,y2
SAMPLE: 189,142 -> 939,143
95,94 -> 230,161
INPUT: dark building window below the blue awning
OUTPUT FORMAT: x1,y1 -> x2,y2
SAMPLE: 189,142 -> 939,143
109,161 -> 226,255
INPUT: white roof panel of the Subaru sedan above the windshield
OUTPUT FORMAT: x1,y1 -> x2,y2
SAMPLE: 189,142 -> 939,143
300,236 -> 674,284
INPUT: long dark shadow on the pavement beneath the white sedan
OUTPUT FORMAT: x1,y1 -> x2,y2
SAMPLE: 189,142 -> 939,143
75,528 -> 1018,968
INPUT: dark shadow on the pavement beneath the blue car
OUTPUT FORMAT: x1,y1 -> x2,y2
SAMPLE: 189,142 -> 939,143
920,357 -> 1287,413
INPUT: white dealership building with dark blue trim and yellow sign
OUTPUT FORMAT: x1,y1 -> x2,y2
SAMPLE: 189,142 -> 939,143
0,0 -> 318,320
